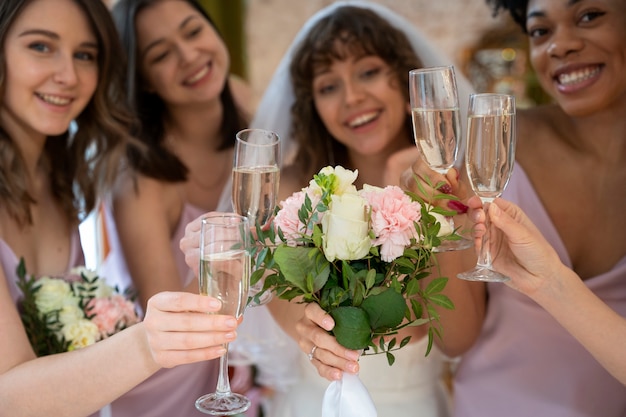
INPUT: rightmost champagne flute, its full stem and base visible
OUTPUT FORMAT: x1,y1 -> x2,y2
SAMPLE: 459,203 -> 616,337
457,94 -> 516,282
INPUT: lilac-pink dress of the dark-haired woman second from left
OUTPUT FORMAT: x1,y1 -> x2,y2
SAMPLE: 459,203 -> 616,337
99,200 -> 219,417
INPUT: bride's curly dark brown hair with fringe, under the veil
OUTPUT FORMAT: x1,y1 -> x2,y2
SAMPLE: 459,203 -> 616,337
290,6 -> 423,179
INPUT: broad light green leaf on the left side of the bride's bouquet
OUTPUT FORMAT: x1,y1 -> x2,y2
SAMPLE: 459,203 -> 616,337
274,245 -> 330,293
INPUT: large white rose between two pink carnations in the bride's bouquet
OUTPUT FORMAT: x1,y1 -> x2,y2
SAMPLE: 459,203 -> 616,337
322,194 -> 372,262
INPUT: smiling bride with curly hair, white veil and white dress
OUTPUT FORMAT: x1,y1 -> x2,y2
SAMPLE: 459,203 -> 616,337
236,2 -> 471,417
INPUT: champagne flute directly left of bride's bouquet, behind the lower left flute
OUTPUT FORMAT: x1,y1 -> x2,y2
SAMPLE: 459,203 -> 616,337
232,129 -> 281,306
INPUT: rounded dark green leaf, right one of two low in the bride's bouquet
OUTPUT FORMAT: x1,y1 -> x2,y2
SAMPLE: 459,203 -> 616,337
361,289 -> 406,329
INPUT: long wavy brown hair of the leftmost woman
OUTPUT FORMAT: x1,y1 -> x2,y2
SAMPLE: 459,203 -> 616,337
0,0 -> 134,225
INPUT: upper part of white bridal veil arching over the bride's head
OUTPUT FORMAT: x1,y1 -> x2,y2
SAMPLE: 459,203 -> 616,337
250,0 -> 473,165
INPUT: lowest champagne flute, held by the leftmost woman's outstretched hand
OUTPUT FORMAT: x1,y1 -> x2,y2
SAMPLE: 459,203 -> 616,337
196,213 -> 251,416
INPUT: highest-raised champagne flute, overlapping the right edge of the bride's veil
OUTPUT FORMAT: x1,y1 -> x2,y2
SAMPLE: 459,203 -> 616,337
409,66 -> 472,252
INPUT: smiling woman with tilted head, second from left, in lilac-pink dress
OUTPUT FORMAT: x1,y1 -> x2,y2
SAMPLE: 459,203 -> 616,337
101,0 -> 251,417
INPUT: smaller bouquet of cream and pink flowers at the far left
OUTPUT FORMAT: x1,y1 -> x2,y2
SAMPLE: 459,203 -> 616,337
17,259 -> 139,356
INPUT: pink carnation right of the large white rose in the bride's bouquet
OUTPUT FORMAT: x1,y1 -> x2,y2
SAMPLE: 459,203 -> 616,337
361,186 -> 421,262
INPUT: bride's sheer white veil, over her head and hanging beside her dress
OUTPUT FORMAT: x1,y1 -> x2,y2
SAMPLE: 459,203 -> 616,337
239,1 -> 472,402
